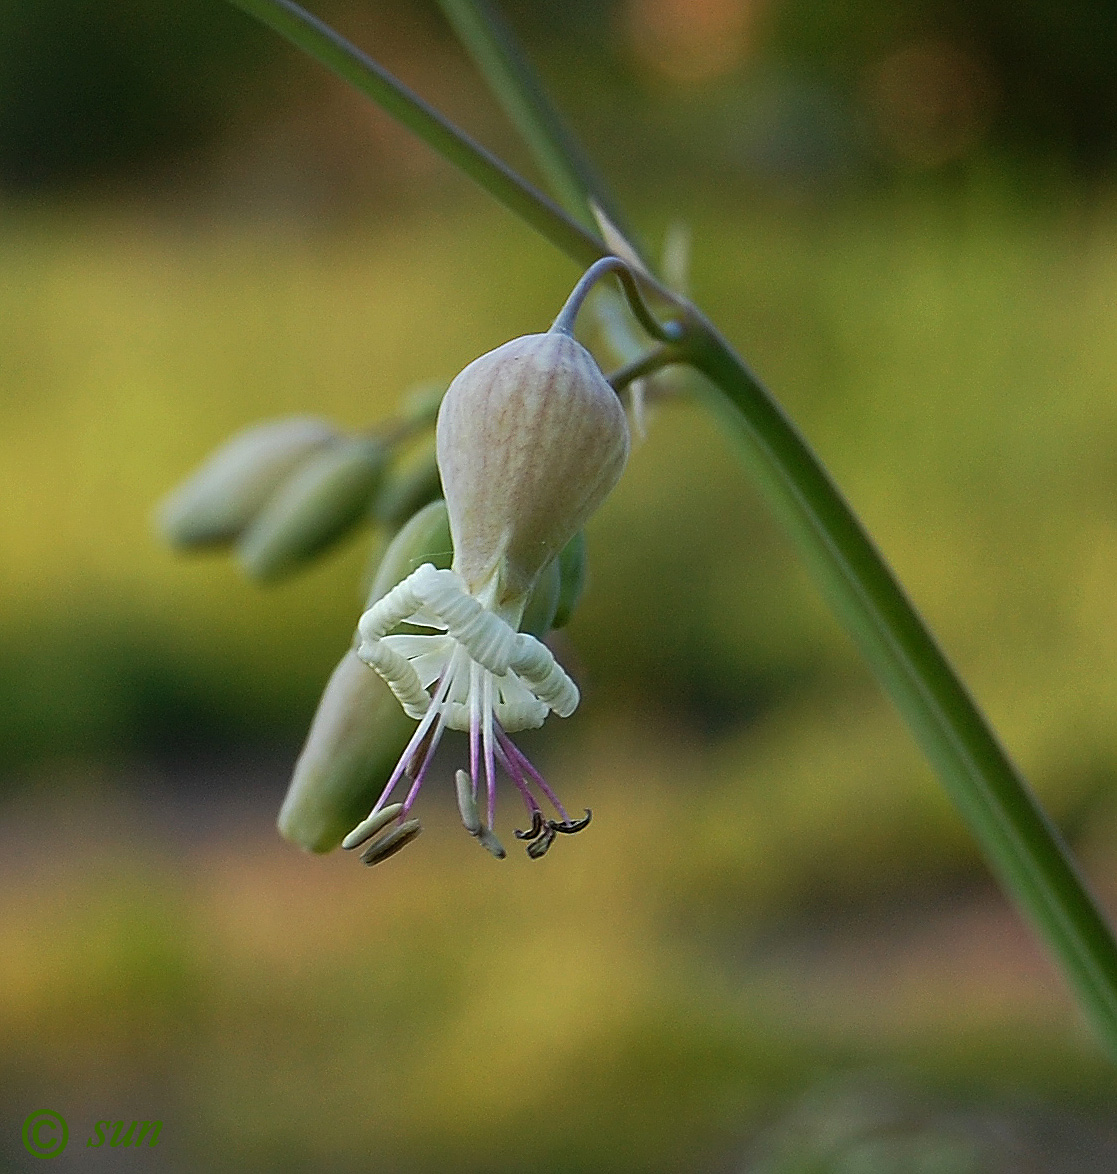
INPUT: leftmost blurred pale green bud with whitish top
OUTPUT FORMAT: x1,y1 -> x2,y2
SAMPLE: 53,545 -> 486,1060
157,416 -> 337,549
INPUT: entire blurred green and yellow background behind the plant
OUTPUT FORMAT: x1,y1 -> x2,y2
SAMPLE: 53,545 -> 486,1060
0,0 -> 1117,1174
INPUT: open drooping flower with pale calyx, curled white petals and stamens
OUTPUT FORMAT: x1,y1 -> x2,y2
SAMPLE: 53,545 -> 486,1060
344,318 -> 628,863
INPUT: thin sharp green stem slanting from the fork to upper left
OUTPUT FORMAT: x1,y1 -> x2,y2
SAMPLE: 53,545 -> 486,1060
230,0 -> 608,266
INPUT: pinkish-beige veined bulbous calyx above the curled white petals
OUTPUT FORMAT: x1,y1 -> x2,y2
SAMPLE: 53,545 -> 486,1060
437,330 -> 628,609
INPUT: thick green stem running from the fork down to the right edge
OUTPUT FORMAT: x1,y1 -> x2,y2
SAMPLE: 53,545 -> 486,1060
681,315 -> 1117,1060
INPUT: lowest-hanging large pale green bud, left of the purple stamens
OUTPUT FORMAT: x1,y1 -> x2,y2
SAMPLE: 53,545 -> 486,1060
278,652 -> 415,852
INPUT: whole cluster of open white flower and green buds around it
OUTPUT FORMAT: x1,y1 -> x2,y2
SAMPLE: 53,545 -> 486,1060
160,257 -> 650,864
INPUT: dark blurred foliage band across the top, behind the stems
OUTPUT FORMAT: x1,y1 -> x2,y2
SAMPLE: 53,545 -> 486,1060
0,0 -> 1117,192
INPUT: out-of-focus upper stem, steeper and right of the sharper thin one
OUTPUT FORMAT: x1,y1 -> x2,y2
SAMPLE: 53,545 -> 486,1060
429,0 -> 632,239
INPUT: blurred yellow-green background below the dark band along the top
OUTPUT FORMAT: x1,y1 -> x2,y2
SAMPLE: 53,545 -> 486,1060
0,36 -> 1117,1174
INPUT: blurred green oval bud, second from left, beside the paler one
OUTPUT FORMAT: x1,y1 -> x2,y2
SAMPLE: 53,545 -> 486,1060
237,437 -> 385,581
